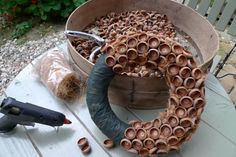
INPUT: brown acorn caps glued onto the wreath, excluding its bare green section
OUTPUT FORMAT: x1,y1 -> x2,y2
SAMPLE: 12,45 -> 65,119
102,32 -> 205,156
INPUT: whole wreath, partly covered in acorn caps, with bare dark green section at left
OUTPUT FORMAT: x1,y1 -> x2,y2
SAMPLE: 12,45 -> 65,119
87,32 -> 205,155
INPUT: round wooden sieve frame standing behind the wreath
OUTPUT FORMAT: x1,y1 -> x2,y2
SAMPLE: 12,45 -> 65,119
65,0 -> 219,109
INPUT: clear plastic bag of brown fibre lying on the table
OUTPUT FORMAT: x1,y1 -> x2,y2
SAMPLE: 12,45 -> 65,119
33,48 -> 84,102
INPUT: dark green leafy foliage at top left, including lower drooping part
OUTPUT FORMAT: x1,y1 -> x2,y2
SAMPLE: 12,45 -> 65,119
0,0 -> 87,38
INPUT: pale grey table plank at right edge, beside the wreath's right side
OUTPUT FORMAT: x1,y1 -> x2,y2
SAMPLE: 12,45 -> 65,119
202,83 -> 236,145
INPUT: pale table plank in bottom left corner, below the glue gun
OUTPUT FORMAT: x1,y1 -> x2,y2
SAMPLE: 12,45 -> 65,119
0,126 -> 40,157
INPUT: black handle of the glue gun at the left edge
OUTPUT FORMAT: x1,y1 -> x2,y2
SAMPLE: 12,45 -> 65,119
0,115 -> 17,133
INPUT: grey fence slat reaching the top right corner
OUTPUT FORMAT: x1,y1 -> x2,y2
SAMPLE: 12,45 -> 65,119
216,0 -> 236,31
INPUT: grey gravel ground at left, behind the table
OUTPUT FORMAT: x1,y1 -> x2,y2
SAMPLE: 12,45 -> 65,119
0,31 -> 65,95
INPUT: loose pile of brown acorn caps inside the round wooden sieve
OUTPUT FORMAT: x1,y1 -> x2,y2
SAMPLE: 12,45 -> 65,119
72,10 -> 176,63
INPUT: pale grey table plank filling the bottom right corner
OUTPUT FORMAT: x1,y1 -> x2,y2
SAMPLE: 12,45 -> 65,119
180,123 -> 236,157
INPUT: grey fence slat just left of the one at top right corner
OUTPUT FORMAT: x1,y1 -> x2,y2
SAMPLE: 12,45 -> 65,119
207,0 -> 225,24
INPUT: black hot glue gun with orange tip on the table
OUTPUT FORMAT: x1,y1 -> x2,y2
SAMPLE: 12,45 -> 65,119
0,97 -> 71,133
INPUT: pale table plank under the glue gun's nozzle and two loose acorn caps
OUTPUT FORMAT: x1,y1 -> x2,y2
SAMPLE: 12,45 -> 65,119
7,65 -> 109,157
